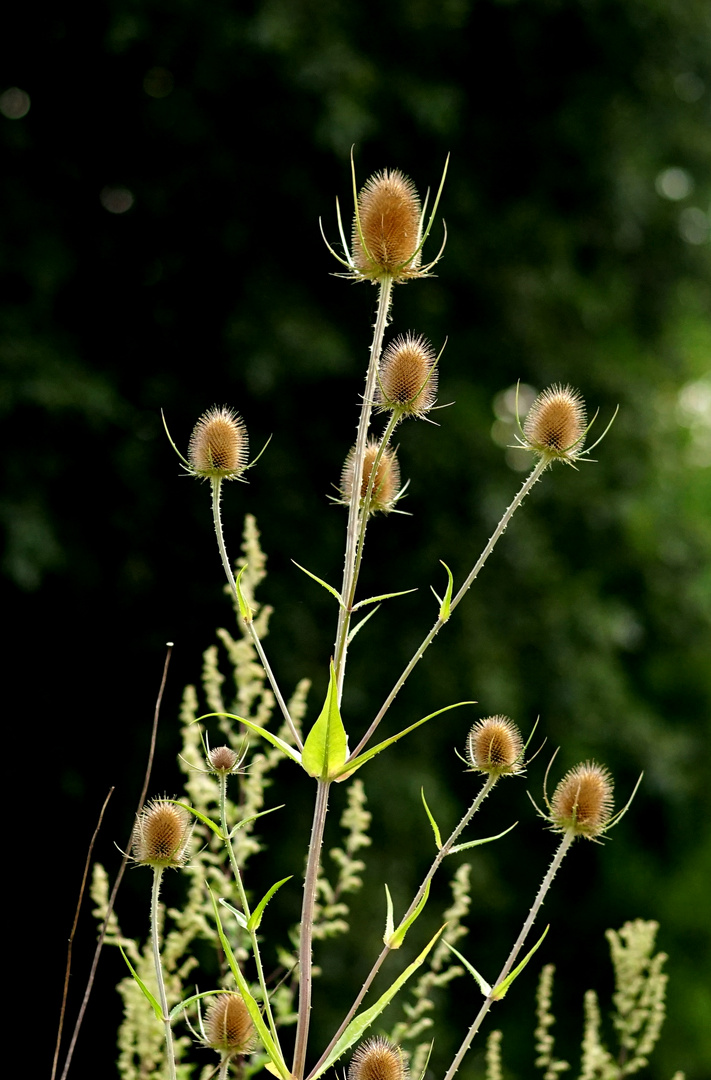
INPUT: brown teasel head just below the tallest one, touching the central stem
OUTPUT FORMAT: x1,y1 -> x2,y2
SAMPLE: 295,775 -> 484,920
375,334 -> 437,418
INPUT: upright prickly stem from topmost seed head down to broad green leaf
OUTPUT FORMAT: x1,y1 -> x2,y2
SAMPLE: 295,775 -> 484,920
334,276 -> 392,700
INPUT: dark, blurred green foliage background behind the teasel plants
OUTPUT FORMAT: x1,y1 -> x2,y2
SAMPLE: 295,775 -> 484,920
0,0 -> 711,1080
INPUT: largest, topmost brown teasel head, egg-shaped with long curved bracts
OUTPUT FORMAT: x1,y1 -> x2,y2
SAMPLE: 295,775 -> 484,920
351,168 -> 421,281
